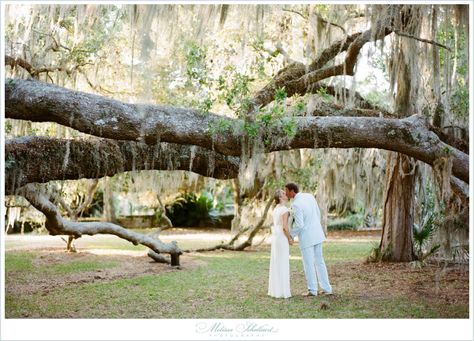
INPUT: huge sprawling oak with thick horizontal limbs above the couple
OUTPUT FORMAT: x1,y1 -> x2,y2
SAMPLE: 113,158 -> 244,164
5,5 -> 469,261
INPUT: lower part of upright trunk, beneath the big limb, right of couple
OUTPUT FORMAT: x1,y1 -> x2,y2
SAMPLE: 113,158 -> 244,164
380,153 -> 416,262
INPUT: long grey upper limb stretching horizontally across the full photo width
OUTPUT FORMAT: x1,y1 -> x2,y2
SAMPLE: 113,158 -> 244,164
5,80 -> 469,183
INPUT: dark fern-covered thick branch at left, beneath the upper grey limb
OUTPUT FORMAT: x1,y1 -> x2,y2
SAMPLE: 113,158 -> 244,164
5,137 -> 240,194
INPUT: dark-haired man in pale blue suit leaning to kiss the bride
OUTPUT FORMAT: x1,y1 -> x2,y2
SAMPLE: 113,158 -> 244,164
285,183 -> 332,296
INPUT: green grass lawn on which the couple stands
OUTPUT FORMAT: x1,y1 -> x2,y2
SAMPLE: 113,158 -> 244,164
5,232 -> 469,318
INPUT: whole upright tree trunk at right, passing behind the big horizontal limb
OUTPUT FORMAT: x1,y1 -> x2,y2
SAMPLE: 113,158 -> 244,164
380,6 -> 421,262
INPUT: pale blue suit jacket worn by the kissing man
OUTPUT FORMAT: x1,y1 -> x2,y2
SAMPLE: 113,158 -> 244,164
290,193 -> 326,249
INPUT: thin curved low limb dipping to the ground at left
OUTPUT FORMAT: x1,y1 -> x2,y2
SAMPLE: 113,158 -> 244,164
18,184 -> 182,262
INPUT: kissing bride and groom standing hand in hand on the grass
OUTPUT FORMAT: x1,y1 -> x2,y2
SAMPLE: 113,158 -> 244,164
268,183 -> 332,298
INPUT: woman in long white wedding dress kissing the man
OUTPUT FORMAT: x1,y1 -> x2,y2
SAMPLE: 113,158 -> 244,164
268,189 -> 293,298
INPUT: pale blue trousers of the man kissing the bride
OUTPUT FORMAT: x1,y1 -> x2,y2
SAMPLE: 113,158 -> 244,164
301,243 -> 332,295
